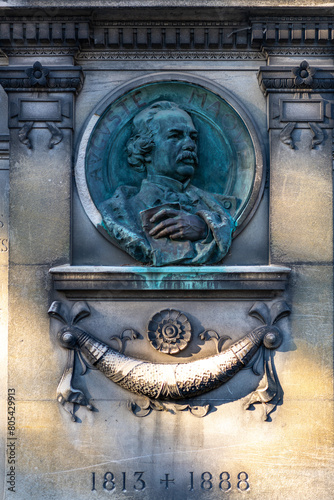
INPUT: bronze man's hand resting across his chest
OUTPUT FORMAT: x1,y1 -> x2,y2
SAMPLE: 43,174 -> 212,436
149,208 -> 208,241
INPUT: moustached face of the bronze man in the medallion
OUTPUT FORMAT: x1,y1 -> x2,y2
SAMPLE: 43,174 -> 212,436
147,110 -> 198,182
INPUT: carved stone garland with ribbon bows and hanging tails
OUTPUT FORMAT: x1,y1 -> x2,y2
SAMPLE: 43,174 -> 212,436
49,301 -> 290,421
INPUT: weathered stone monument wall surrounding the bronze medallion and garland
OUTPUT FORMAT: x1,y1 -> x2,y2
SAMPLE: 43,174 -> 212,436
0,0 -> 334,500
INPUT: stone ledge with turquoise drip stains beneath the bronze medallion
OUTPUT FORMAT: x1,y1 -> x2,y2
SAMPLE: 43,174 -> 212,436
50,265 -> 290,300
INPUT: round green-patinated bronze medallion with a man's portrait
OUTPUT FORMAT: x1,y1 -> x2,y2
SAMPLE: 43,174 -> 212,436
76,74 -> 264,266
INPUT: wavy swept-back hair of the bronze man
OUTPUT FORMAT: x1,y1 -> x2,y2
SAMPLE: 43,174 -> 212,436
126,101 -> 183,172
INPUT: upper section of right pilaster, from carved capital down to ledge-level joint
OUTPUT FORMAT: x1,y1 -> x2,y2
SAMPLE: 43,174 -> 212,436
259,61 -> 334,264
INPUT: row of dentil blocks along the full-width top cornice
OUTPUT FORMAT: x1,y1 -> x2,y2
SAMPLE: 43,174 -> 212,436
0,17 -> 333,53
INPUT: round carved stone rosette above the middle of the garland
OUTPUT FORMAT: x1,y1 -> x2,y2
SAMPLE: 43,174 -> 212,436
147,309 -> 191,354
